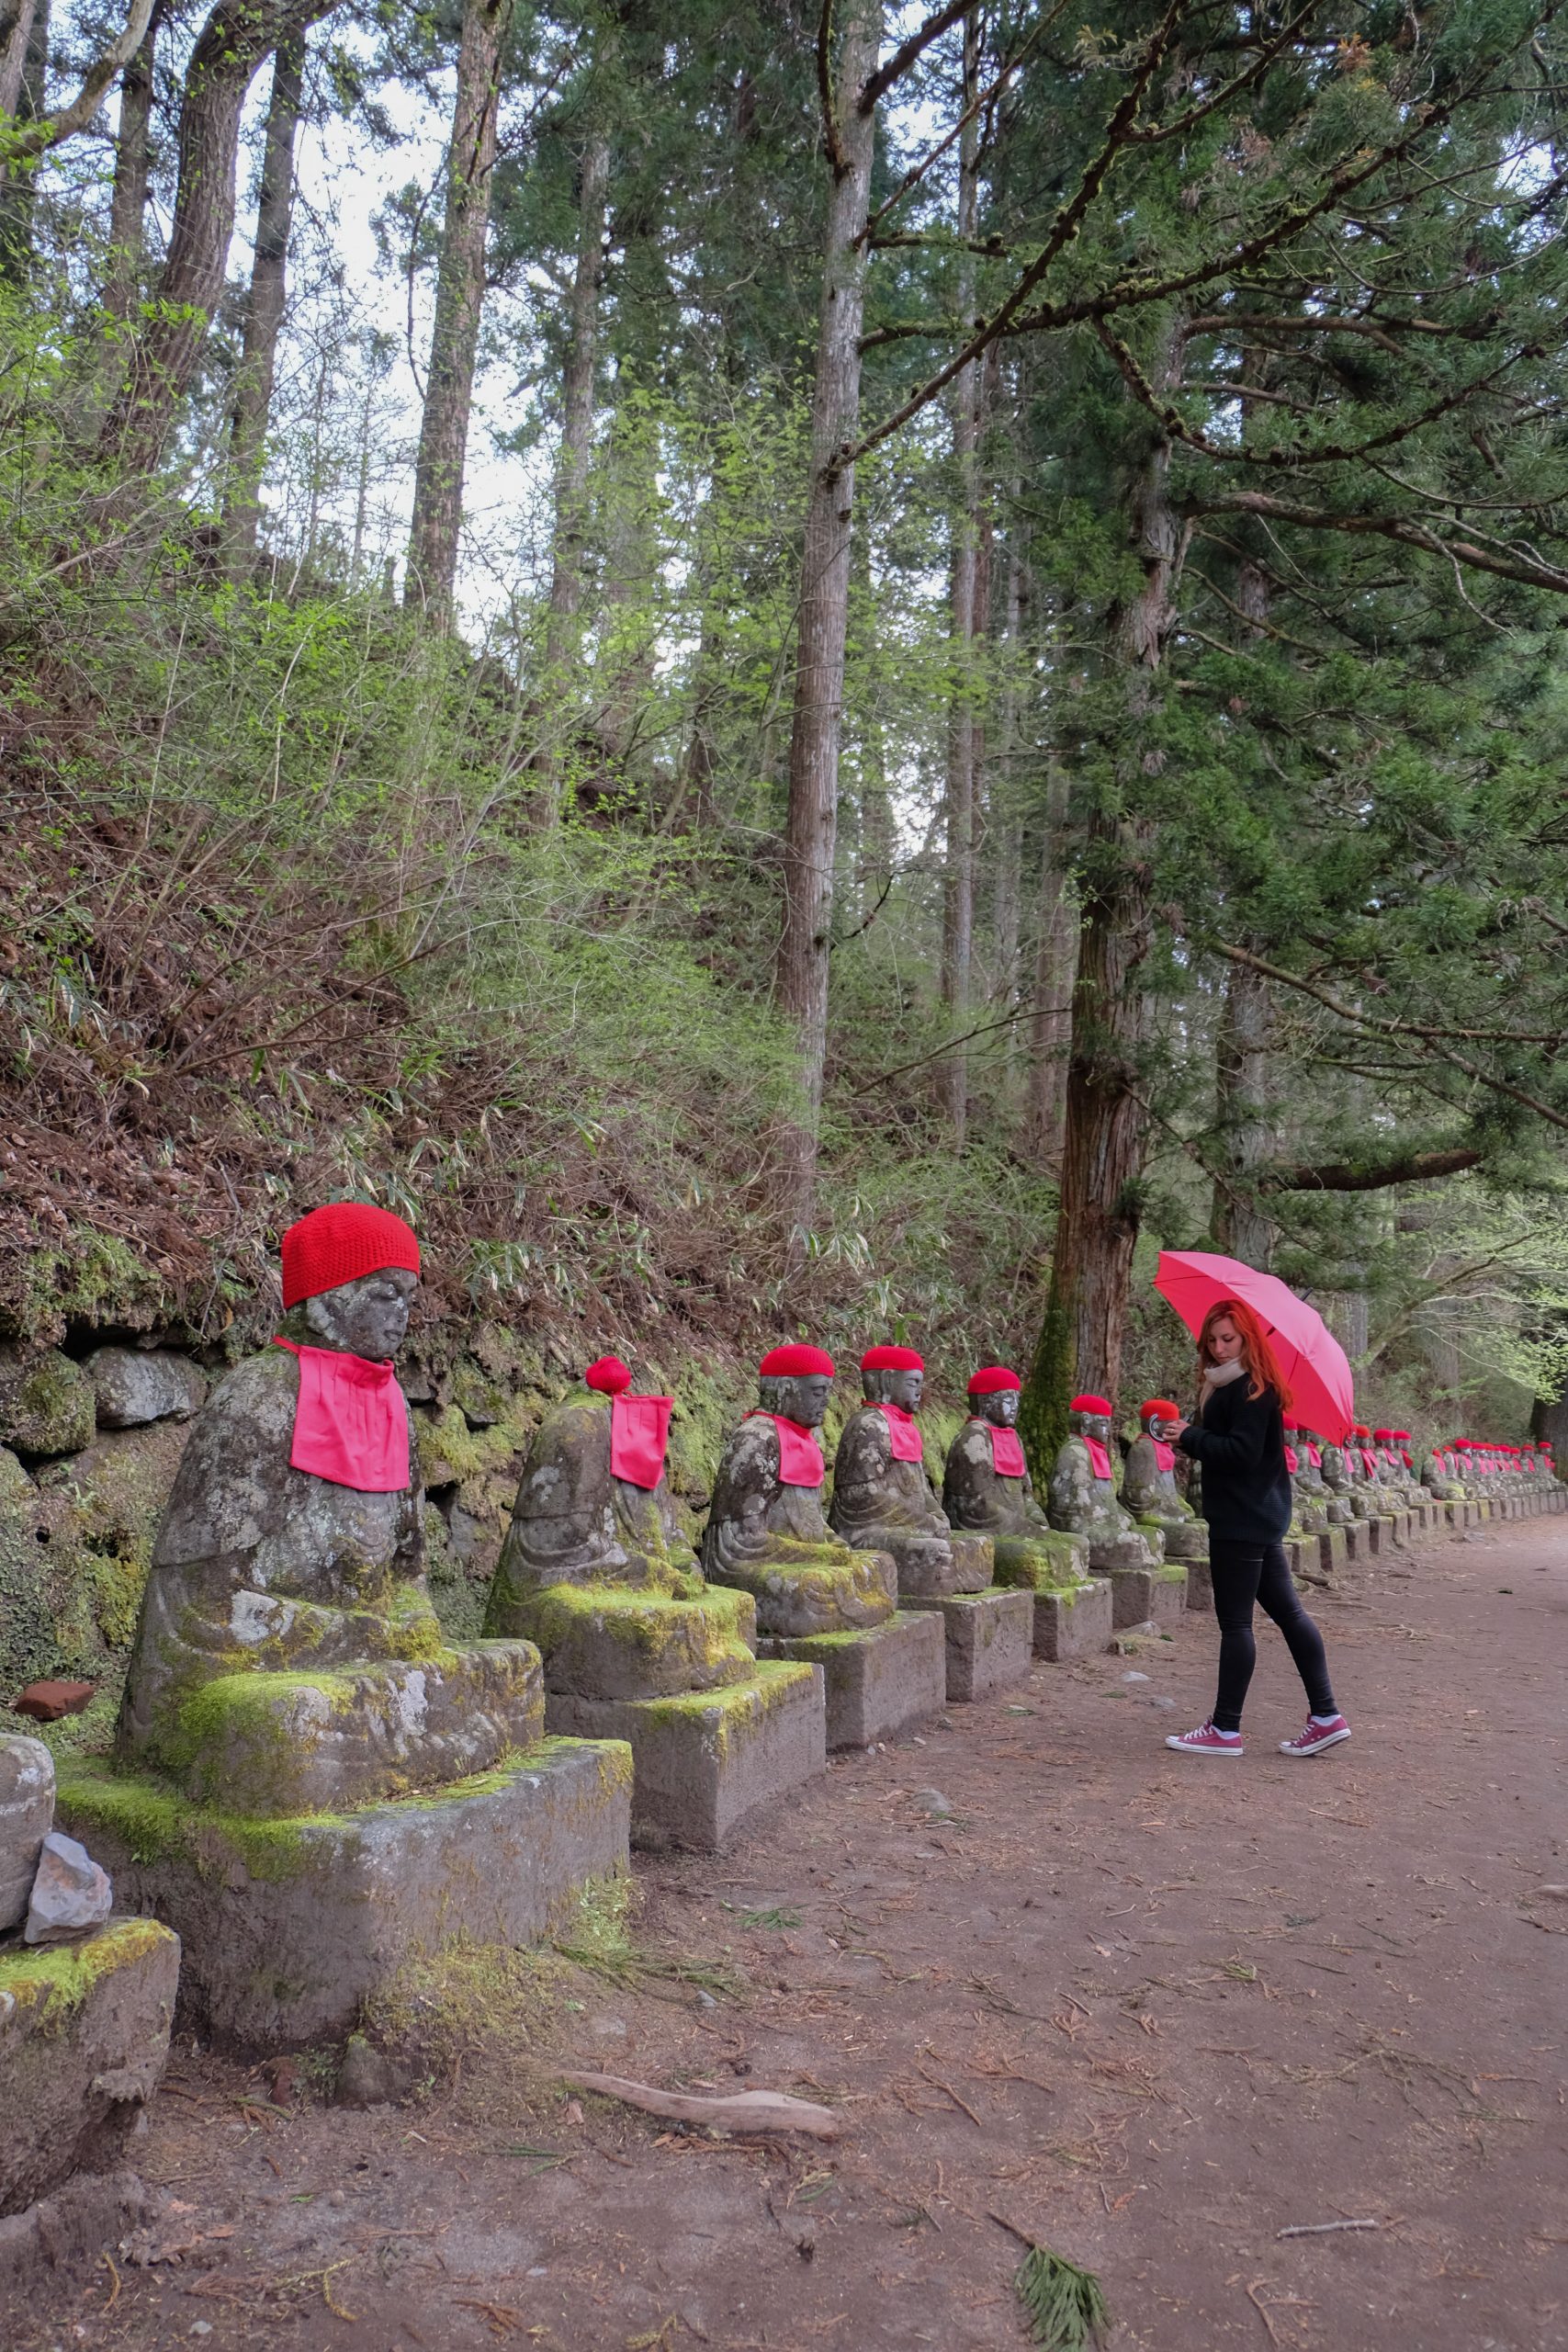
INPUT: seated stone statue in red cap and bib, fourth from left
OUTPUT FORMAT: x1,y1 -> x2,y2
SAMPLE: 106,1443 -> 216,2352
828,1348 -> 992,1600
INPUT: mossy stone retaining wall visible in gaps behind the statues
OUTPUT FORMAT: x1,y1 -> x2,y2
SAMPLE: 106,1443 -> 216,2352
0,1322 -> 962,1743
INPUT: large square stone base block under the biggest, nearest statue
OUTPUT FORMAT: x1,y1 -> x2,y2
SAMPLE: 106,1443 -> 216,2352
56,1740 -> 632,2049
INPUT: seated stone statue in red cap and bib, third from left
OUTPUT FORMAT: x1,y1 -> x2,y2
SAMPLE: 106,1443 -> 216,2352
703,1345 -> 898,1637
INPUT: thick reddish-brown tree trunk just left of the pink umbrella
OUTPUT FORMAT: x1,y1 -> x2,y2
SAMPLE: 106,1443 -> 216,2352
1018,332 -> 1180,1477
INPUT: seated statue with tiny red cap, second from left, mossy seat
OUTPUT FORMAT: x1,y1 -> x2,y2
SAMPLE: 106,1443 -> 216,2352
484,1355 -> 757,1698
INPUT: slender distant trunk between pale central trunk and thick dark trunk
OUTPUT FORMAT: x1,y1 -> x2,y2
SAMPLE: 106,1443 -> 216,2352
941,14 -> 983,1146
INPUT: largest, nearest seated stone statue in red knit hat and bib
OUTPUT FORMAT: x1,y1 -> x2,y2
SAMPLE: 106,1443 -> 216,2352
118,1202 -> 543,1814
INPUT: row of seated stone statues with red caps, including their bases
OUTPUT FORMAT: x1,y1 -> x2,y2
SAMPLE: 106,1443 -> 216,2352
59,1202 -> 1561,2044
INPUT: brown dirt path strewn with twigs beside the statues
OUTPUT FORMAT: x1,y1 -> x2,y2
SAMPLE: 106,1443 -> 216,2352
0,1520 -> 1568,2352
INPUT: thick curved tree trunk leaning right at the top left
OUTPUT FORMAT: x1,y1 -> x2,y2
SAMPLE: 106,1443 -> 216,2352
98,0 -> 333,478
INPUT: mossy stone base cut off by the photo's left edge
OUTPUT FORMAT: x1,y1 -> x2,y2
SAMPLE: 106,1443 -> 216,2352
0,1909 -> 179,2213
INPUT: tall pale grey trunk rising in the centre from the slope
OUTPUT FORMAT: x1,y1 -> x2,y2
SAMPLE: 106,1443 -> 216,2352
778,0 -> 882,1256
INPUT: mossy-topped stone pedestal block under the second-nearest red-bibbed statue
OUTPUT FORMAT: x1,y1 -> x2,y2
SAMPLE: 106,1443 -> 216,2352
546,1658 -> 828,1851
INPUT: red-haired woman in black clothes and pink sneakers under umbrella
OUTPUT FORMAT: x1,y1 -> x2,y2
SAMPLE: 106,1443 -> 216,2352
1166,1298 -> 1349,1757
